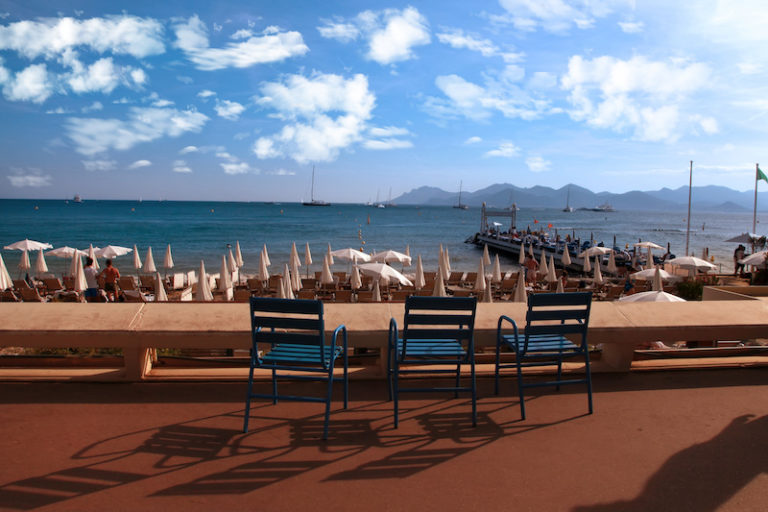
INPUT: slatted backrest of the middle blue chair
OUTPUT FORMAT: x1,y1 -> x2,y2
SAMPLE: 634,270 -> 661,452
401,295 -> 477,357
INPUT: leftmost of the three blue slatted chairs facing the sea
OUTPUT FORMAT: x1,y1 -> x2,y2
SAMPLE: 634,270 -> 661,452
243,297 -> 349,439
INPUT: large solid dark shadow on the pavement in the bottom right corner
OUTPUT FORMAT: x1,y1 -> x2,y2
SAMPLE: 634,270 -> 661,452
573,415 -> 768,512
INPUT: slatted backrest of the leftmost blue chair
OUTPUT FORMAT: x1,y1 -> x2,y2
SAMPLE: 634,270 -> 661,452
251,297 -> 333,368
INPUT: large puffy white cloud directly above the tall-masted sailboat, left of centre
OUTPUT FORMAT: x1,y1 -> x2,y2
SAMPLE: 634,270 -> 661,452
253,74 -> 376,163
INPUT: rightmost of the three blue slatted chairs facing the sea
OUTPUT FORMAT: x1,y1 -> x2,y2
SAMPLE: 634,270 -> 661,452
495,293 -> 592,419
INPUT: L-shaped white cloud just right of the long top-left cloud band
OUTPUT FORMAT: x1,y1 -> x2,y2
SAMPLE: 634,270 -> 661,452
174,15 -> 309,71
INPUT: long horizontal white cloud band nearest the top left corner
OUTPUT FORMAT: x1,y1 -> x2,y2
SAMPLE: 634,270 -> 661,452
0,15 -> 165,59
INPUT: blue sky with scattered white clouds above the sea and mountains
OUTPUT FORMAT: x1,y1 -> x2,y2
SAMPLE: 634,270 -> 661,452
0,0 -> 768,202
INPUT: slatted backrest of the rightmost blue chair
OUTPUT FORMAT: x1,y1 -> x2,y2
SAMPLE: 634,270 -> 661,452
523,292 -> 592,352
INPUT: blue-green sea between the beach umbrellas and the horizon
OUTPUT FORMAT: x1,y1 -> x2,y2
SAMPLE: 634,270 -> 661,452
0,199 -> 766,277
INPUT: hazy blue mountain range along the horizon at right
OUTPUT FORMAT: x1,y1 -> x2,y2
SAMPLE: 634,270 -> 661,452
392,183 -> 768,212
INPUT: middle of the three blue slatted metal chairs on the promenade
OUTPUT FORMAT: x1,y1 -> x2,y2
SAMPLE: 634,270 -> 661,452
387,296 -> 477,428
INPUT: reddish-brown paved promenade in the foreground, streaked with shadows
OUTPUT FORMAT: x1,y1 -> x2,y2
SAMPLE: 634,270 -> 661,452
0,368 -> 768,512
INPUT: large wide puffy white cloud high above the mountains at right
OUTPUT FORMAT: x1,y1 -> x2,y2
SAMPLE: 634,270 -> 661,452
561,55 -> 712,141
